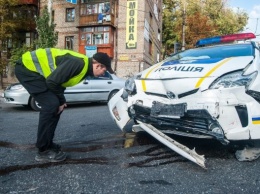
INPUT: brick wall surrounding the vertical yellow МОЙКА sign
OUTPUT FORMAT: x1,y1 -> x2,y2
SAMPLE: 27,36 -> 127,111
115,0 -> 162,77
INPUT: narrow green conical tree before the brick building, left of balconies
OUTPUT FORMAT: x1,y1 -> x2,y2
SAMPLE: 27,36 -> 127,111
35,6 -> 58,48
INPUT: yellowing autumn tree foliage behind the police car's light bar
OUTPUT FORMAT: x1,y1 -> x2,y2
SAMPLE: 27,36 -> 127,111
162,0 -> 248,54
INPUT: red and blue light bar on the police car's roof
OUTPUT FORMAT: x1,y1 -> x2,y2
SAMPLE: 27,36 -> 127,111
196,33 -> 256,47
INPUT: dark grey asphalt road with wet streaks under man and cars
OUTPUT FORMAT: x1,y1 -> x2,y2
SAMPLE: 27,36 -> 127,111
0,96 -> 260,194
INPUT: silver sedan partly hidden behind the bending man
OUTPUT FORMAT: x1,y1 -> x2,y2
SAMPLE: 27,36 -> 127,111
3,72 -> 125,111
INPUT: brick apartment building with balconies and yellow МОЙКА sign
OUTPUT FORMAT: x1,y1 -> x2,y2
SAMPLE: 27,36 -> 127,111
39,0 -> 162,77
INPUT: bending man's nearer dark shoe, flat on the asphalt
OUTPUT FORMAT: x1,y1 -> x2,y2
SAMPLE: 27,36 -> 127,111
35,150 -> 67,162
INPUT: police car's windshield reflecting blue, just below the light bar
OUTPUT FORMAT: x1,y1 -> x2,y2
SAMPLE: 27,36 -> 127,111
168,44 -> 254,60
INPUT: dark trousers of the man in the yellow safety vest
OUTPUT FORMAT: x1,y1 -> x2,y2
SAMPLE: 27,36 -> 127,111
15,62 -> 60,151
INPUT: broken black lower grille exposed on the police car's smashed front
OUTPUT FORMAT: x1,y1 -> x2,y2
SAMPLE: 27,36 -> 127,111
129,104 -> 227,144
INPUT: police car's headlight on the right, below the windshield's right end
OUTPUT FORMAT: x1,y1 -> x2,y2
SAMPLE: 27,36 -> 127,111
209,71 -> 257,89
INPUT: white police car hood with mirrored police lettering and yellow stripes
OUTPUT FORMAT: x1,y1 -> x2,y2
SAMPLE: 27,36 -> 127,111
140,56 -> 253,93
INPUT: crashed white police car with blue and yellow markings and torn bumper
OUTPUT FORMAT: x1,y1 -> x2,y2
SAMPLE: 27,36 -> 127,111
108,33 -> 260,168
